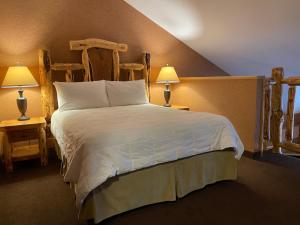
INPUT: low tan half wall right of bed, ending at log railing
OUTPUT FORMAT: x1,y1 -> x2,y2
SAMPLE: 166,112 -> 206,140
151,76 -> 263,152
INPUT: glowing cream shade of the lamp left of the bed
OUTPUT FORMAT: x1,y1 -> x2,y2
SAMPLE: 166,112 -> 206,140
1,66 -> 38,88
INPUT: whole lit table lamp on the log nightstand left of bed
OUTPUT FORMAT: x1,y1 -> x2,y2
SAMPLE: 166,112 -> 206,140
1,66 -> 38,121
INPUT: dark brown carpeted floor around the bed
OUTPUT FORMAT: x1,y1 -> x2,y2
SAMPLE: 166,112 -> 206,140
0,151 -> 300,225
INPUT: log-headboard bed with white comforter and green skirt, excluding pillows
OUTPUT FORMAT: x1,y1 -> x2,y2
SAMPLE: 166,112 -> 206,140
40,39 -> 244,223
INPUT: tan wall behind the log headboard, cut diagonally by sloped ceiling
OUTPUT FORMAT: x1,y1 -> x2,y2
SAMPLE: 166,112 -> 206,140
0,0 -> 226,120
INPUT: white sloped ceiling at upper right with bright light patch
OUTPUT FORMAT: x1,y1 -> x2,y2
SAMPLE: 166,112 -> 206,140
125,0 -> 300,75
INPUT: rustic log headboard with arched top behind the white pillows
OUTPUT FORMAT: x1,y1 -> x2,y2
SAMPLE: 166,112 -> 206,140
39,39 -> 151,122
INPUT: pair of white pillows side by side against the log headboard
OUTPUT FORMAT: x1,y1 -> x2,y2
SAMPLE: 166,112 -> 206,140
54,80 -> 149,111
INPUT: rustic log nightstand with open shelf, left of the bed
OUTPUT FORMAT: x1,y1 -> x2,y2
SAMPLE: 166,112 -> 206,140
0,117 -> 48,172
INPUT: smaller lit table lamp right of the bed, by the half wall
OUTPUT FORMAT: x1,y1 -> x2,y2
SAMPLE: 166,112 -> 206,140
156,65 -> 179,107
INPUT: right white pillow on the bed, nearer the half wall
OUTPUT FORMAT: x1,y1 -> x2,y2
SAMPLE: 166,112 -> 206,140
105,80 -> 149,106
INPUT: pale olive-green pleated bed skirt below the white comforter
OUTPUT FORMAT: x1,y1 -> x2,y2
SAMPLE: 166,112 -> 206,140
79,150 -> 237,223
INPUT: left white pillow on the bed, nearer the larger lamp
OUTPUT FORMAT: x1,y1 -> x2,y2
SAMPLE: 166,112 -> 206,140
53,80 -> 109,111
